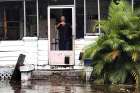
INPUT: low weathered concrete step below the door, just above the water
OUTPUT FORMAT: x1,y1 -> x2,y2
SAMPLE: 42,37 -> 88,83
32,69 -> 82,80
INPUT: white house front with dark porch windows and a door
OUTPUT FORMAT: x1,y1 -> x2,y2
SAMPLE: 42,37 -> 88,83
0,0 -> 137,69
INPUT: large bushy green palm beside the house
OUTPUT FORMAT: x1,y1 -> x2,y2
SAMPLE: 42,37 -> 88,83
83,0 -> 140,85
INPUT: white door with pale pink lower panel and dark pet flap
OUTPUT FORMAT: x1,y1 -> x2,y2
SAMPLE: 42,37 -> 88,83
48,5 -> 75,66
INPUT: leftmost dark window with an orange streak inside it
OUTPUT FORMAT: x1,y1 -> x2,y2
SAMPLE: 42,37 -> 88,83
0,1 -> 24,40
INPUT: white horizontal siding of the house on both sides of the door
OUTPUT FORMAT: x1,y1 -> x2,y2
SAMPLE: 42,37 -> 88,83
0,37 -> 97,66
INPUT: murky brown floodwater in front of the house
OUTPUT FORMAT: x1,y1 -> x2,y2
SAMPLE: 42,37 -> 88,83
0,80 -> 137,93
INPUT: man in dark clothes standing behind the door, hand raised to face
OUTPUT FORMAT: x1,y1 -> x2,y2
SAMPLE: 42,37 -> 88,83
56,16 -> 72,50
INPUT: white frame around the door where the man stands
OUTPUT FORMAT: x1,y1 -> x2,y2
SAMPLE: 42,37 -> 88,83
48,5 -> 76,65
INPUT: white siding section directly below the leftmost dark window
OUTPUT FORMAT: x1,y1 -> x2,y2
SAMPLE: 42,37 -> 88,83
0,41 -> 24,66
